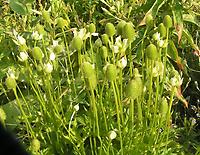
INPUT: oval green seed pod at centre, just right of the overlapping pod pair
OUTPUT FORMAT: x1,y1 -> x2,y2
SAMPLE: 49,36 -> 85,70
106,64 -> 117,81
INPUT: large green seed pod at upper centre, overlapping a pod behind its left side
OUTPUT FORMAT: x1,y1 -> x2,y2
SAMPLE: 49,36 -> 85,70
122,22 -> 135,41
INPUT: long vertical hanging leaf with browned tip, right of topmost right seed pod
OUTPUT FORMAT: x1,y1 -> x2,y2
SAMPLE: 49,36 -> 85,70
172,0 -> 183,43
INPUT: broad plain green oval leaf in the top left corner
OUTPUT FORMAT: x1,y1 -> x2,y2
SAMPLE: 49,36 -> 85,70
9,0 -> 28,15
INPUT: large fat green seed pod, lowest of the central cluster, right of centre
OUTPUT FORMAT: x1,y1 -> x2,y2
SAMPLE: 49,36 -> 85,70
125,77 -> 143,100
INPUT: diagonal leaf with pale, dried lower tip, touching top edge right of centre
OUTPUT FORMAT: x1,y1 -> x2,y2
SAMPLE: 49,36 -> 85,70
139,0 -> 166,26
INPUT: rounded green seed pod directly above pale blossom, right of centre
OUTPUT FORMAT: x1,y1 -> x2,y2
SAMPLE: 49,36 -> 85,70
146,44 -> 158,60
